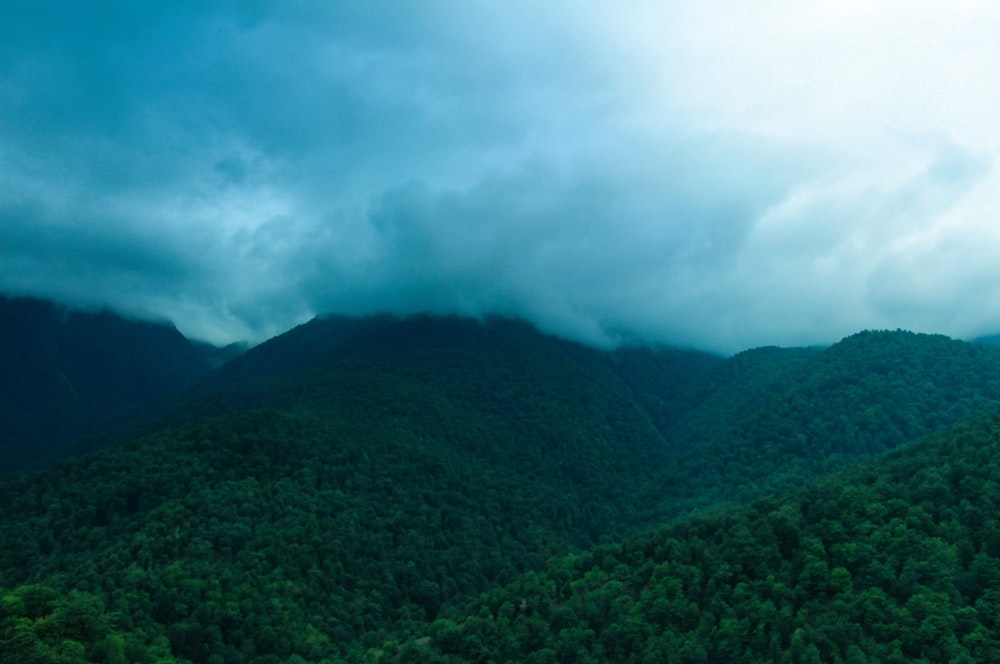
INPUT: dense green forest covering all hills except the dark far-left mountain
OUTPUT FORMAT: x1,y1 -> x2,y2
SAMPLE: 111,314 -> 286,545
0,317 -> 1000,664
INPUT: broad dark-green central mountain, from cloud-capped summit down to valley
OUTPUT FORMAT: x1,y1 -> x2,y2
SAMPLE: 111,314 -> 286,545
0,318 -> 680,662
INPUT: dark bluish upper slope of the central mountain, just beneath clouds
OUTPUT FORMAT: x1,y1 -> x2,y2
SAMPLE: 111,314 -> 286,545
178,317 -> 680,506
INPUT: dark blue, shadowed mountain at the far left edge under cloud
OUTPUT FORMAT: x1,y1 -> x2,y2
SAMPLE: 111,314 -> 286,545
0,296 -> 209,472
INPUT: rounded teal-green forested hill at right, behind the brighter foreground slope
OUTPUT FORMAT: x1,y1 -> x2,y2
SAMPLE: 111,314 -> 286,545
647,331 -> 1000,520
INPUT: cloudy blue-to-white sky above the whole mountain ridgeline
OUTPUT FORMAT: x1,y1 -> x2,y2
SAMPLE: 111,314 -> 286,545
0,0 -> 1000,352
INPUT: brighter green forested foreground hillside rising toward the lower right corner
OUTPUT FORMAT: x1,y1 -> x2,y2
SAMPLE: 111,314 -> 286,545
400,416 -> 1000,663
